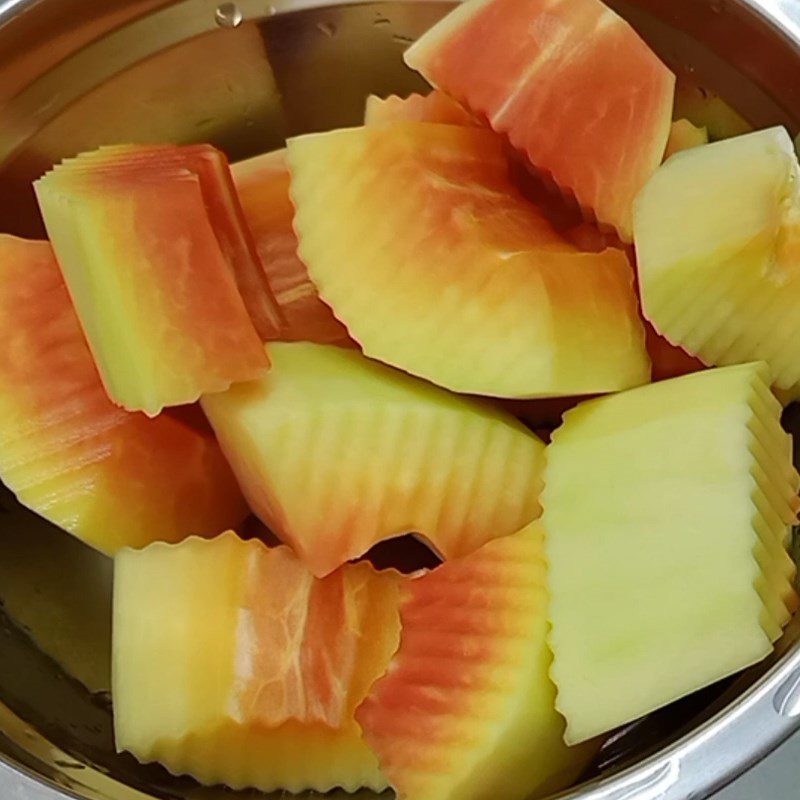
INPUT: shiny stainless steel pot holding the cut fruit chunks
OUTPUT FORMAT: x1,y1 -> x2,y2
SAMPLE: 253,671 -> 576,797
0,0 -> 800,800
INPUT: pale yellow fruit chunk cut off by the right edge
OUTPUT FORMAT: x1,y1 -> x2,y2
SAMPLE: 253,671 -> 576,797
636,128 -> 800,393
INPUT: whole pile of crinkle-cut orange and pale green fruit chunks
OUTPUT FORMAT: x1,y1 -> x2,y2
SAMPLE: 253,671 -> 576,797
0,0 -> 800,800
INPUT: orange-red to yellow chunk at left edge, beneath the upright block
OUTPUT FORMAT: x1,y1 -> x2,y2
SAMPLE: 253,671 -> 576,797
0,235 -> 248,554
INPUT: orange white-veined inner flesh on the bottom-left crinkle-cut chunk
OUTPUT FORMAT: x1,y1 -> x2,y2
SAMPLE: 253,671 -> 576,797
237,547 -> 399,728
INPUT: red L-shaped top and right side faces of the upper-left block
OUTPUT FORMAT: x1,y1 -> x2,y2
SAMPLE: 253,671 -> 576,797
51,144 -> 285,341
